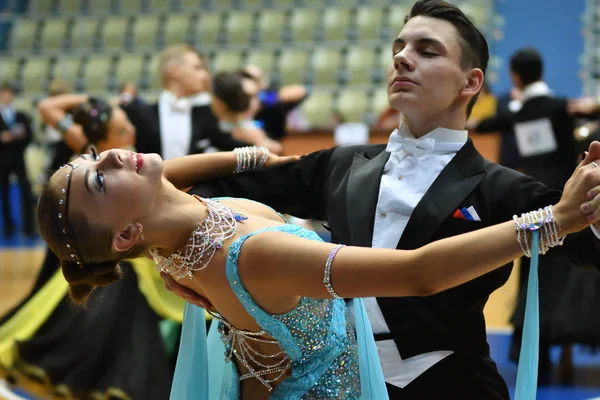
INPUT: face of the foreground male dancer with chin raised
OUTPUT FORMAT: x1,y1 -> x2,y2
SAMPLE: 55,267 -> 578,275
388,16 -> 470,119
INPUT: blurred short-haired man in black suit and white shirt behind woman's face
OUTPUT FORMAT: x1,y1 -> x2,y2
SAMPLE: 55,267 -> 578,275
121,45 -> 268,159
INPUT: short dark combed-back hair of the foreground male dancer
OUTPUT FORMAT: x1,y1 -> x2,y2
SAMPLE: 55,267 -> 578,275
406,0 -> 490,115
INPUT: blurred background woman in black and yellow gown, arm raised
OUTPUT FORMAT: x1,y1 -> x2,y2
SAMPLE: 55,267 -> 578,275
0,94 -> 178,400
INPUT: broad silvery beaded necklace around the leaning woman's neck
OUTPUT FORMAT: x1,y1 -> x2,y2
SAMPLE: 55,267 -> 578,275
150,196 -> 248,279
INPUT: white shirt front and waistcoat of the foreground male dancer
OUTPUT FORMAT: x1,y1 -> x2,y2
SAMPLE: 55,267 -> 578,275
364,124 -> 468,388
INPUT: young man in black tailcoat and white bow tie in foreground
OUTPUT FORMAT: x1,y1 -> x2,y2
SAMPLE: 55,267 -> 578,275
163,0 -> 600,400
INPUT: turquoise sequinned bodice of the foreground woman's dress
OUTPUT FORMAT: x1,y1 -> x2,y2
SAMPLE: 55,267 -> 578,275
219,225 -> 360,399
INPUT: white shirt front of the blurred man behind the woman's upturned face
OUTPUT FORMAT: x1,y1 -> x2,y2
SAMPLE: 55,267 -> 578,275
158,90 -> 210,160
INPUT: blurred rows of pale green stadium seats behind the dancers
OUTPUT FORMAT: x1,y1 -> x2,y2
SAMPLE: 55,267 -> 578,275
0,0 -> 492,124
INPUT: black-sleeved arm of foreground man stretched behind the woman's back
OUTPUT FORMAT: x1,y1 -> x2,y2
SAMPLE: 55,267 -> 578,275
190,149 -> 335,219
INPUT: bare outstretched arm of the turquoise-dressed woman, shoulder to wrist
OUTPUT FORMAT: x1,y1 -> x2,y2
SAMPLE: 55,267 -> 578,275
239,222 -> 522,298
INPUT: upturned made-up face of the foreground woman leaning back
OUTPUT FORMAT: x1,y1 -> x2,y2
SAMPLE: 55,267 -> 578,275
51,149 -> 163,238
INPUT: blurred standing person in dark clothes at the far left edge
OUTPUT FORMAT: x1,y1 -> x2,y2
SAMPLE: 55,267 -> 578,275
0,83 -> 34,237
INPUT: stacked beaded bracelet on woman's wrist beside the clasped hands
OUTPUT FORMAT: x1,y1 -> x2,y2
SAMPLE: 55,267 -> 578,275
513,206 -> 565,257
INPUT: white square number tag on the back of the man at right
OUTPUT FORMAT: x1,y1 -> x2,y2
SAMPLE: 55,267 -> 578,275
515,118 -> 557,157
